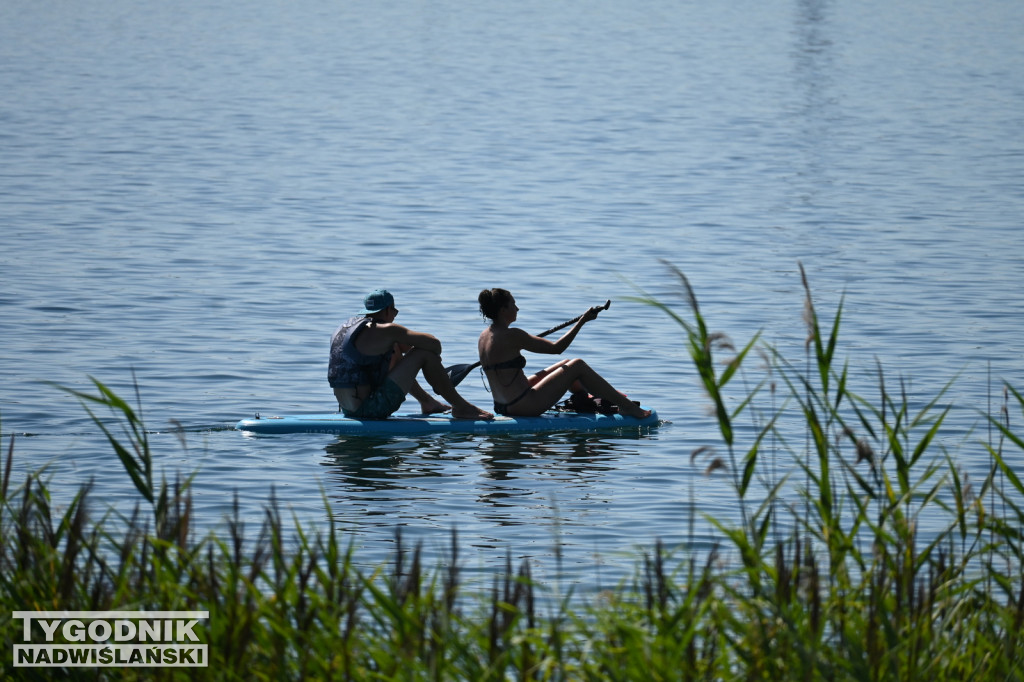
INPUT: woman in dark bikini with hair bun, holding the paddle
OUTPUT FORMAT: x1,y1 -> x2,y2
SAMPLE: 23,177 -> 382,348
477,289 -> 650,419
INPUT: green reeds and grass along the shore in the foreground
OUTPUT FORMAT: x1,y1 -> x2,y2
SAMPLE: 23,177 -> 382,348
0,265 -> 1024,682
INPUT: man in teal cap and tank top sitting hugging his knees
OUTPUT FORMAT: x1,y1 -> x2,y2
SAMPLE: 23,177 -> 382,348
327,289 -> 494,419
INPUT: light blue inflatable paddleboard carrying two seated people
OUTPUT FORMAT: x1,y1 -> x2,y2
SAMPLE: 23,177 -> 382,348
234,408 -> 658,435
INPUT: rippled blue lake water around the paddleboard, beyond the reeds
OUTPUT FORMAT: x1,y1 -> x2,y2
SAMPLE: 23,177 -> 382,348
0,0 -> 1024,588
